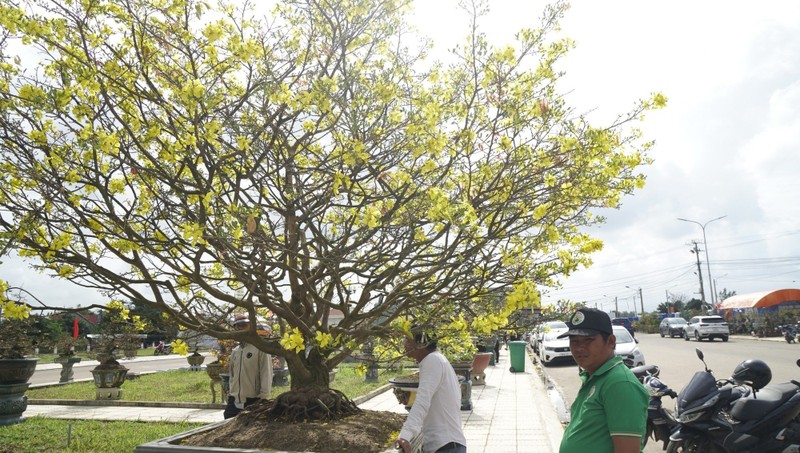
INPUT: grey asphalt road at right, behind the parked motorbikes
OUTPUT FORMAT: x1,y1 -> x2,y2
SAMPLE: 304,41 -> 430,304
544,333 -> 800,453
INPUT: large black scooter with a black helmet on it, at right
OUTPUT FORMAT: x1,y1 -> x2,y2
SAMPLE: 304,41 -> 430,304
667,349 -> 800,453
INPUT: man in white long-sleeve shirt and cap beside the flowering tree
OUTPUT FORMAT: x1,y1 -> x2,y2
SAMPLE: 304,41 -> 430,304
395,332 -> 467,453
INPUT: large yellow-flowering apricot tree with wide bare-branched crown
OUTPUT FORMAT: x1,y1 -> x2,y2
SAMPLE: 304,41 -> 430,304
0,0 -> 665,417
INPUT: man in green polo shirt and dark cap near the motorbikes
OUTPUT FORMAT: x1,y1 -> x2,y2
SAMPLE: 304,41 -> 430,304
559,308 -> 648,453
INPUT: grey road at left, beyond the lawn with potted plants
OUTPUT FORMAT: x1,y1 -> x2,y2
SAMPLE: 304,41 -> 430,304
29,354 -> 208,386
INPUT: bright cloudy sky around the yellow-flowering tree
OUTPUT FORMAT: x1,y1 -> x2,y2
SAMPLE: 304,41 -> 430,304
0,0 -> 800,312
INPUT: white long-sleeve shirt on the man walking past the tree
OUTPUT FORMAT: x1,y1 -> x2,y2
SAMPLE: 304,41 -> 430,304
398,351 -> 467,453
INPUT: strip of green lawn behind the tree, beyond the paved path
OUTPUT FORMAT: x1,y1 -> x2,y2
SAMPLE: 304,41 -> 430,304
25,364 -> 409,403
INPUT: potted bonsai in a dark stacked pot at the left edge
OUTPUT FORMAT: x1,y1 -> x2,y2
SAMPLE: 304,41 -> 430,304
0,292 -> 39,426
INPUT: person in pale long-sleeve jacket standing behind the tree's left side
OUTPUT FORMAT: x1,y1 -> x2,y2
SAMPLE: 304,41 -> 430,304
223,315 -> 272,419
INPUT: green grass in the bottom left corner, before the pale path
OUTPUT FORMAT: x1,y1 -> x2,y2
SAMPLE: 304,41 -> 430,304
0,416 -> 203,453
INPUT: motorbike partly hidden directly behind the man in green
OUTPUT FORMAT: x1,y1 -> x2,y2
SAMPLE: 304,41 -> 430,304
631,365 -> 678,450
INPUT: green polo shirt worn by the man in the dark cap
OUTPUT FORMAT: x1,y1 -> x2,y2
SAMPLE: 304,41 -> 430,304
559,356 -> 649,453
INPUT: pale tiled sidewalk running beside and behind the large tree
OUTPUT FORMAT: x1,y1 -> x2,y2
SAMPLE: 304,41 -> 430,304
25,350 -> 563,453
